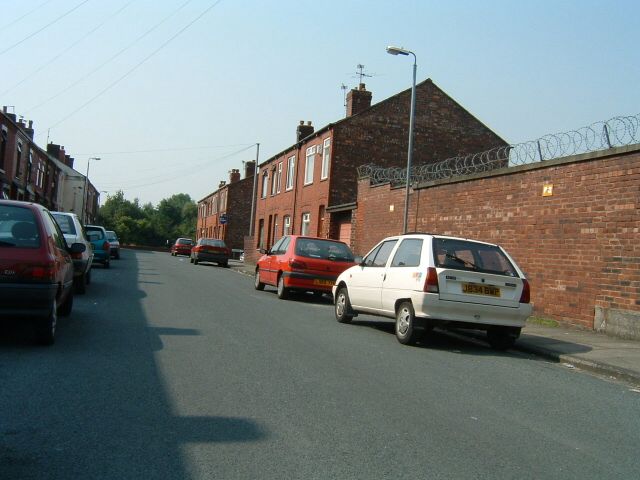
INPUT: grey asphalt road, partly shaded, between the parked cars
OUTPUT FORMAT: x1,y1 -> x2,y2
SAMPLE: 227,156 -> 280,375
0,250 -> 640,480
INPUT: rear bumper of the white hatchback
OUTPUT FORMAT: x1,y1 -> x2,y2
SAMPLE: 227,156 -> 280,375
411,293 -> 533,328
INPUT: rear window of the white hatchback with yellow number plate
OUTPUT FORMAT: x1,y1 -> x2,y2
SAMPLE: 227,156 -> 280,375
433,238 -> 518,277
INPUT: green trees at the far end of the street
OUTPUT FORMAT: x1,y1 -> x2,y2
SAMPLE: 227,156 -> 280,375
98,190 -> 198,246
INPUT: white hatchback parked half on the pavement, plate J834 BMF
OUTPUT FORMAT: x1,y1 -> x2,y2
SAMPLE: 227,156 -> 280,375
333,233 -> 532,350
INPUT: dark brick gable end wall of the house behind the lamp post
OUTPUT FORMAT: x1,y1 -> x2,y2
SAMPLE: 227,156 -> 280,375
330,80 -> 506,206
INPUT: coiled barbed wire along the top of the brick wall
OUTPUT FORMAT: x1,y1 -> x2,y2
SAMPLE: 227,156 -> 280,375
358,114 -> 640,185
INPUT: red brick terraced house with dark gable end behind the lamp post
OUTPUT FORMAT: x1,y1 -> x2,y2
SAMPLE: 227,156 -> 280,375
244,79 -> 506,262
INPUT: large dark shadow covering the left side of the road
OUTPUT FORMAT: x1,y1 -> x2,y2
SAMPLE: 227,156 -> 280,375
0,250 -> 268,480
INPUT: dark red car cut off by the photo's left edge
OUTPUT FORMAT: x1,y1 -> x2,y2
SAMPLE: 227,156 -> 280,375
0,200 -> 86,345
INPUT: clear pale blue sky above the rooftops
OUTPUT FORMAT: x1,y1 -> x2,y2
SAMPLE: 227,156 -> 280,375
0,0 -> 640,204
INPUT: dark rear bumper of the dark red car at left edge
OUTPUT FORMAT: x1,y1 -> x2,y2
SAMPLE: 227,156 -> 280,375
0,283 -> 58,318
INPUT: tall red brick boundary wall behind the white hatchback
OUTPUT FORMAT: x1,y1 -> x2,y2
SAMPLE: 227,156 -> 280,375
354,146 -> 640,328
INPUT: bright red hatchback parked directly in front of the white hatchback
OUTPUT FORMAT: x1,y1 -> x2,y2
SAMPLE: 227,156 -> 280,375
255,235 -> 355,299
